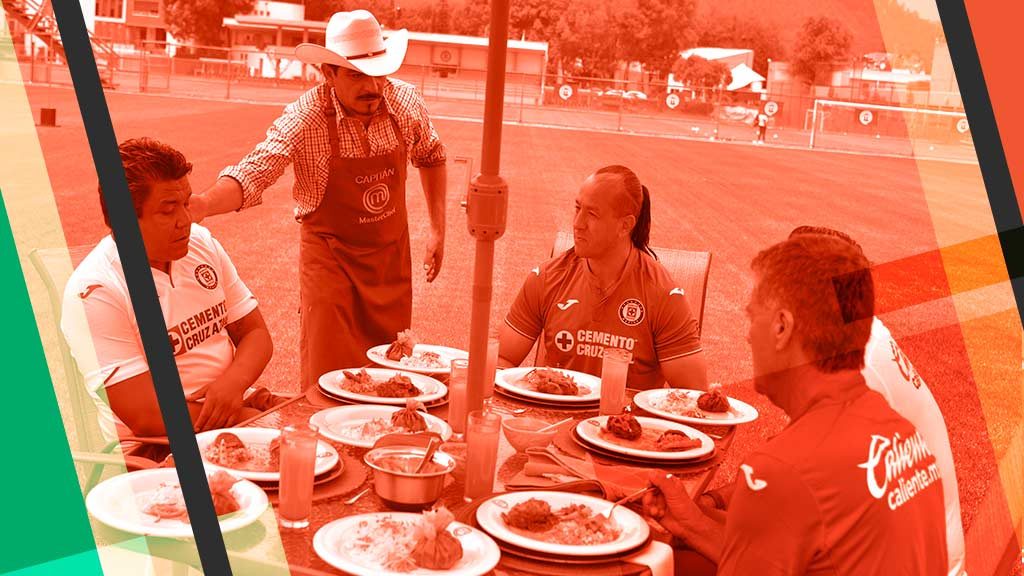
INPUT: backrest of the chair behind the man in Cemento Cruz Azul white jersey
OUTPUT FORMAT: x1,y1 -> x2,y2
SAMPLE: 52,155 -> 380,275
29,246 -> 108,451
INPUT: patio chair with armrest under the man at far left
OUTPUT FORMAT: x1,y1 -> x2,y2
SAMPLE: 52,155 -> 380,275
29,246 -> 167,492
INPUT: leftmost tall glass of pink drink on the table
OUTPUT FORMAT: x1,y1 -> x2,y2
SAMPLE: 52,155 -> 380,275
278,423 -> 318,528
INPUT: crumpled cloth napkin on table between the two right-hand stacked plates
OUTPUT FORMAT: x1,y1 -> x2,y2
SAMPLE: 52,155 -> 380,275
505,446 -> 647,500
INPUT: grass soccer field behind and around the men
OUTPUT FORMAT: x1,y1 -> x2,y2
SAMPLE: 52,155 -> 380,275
30,84 -> 1022,545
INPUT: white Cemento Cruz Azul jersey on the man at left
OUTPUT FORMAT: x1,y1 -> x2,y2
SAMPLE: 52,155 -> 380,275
60,224 -> 257,439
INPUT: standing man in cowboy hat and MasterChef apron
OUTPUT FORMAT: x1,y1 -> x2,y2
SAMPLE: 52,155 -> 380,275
191,10 -> 446,387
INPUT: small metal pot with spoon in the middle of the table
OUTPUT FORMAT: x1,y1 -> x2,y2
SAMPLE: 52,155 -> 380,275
362,446 -> 456,510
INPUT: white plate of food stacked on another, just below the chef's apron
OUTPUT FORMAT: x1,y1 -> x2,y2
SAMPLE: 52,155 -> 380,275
319,368 -> 447,406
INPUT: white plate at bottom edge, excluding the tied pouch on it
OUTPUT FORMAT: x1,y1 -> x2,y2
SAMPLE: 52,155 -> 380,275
313,512 -> 501,576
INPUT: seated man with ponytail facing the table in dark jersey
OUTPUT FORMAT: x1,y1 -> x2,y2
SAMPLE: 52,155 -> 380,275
499,166 -> 708,389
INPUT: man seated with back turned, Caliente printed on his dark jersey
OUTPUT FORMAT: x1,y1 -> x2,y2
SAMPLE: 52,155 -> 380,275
644,236 -> 947,575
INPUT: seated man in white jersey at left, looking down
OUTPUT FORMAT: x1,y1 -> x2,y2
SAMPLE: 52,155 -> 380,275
61,138 -> 276,439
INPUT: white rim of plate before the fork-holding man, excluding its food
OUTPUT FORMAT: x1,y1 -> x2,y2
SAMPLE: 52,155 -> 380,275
476,491 -> 650,557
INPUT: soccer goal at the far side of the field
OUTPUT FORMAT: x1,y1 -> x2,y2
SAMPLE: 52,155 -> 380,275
805,99 -> 974,157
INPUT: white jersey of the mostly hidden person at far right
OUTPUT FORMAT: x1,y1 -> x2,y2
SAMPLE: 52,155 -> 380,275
862,318 -> 964,575
